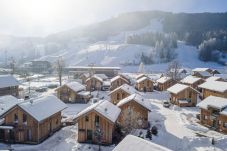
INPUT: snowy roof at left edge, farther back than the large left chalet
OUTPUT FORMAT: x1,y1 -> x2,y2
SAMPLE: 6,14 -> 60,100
0,75 -> 20,88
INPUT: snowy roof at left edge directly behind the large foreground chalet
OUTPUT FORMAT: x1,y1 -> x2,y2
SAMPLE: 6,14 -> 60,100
0,95 -> 22,116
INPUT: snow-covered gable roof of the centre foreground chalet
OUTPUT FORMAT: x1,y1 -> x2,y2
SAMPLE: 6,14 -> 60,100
76,100 -> 121,123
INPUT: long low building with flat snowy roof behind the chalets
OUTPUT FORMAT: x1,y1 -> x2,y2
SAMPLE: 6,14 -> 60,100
65,66 -> 120,78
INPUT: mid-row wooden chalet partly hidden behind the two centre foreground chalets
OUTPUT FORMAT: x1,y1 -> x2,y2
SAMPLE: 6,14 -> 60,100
109,84 -> 138,105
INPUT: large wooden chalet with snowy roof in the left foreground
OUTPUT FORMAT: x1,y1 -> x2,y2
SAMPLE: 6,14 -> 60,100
0,95 -> 67,144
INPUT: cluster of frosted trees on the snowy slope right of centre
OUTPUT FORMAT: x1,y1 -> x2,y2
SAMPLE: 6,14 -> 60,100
126,32 -> 177,64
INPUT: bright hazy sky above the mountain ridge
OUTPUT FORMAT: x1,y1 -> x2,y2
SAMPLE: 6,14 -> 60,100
0,0 -> 227,36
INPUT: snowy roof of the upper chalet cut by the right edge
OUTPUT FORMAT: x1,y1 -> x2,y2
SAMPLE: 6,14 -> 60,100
199,81 -> 227,93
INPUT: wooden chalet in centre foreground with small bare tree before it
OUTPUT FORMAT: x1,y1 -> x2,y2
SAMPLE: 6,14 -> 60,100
75,100 -> 121,144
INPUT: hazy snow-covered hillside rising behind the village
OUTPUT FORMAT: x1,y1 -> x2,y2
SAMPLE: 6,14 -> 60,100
0,11 -> 227,65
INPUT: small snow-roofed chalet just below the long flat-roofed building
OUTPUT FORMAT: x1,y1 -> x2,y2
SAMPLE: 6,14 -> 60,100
85,74 -> 110,91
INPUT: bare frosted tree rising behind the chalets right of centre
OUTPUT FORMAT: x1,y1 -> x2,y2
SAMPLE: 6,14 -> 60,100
167,60 -> 181,80
